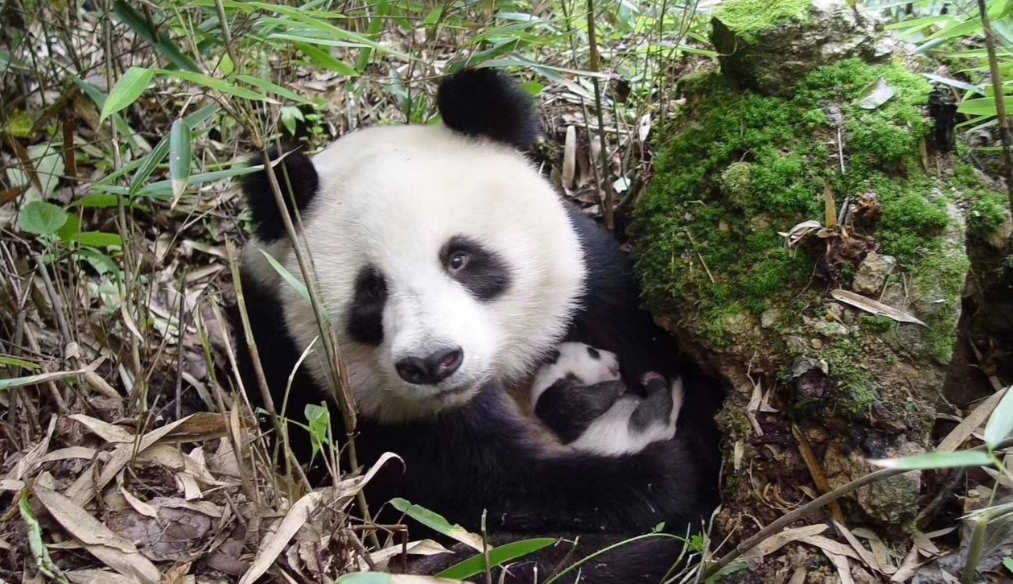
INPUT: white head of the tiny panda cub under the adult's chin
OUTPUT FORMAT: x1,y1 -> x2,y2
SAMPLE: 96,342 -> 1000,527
531,342 -> 620,404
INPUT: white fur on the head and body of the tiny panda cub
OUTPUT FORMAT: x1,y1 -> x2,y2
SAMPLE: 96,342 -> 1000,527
531,342 -> 683,455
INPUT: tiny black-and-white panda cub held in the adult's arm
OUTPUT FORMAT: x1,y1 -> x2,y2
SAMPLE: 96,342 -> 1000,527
531,342 -> 683,455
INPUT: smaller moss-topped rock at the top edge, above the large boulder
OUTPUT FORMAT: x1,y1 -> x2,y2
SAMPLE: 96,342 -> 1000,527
711,0 -> 897,95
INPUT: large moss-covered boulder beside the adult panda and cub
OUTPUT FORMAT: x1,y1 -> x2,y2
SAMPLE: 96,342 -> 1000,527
630,54 -> 1005,531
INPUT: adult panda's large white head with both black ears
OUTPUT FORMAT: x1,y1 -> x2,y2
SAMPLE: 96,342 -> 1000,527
243,69 -> 586,421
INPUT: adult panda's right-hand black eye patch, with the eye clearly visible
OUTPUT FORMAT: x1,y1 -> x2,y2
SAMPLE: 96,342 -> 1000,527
440,235 -> 511,302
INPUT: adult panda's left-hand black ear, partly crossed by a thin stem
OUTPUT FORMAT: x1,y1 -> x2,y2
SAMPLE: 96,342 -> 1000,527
242,148 -> 320,243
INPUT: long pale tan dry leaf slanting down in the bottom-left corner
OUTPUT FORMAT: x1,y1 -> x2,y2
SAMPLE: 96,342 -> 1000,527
32,485 -> 161,584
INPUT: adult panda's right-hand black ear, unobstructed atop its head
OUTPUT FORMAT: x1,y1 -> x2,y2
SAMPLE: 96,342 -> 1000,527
437,69 -> 539,152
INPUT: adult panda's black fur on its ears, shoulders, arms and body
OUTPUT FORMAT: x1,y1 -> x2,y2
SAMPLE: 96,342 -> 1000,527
236,70 -> 716,584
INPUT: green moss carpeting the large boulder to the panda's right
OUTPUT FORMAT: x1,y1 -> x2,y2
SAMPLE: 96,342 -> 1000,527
631,60 -> 947,346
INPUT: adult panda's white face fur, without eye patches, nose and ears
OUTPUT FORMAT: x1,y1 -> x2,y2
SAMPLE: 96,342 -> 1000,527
244,127 -> 586,422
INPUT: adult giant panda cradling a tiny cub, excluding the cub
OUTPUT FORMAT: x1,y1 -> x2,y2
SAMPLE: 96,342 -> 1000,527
237,69 -> 714,583
